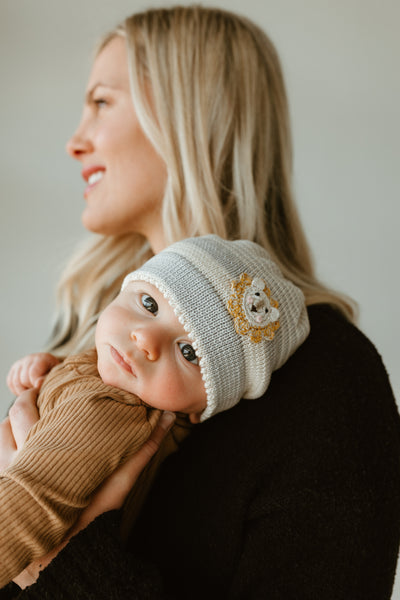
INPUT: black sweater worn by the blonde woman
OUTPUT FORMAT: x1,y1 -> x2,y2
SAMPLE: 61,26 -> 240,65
0,306 -> 400,600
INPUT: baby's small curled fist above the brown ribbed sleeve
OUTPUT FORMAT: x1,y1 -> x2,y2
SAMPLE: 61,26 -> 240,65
7,352 -> 60,396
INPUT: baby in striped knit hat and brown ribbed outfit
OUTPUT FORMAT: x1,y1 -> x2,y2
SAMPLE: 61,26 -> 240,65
0,235 -> 309,587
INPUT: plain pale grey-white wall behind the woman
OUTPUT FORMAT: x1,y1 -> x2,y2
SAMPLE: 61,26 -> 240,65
0,0 -> 400,597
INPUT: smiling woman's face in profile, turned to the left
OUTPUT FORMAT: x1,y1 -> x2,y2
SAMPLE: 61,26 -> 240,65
67,37 -> 167,252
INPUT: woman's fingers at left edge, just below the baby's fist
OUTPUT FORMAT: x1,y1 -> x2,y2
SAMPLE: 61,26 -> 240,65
0,389 -> 39,471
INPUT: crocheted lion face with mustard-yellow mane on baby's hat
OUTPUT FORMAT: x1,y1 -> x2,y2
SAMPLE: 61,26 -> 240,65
227,273 -> 280,344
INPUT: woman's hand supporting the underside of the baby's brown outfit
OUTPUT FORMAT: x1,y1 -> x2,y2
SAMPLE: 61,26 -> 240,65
13,412 -> 175,589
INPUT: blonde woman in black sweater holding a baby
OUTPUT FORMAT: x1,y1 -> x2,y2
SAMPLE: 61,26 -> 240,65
5,7 -> 400,600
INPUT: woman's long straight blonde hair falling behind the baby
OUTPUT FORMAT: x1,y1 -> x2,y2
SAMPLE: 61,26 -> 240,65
52,5 -> 355,354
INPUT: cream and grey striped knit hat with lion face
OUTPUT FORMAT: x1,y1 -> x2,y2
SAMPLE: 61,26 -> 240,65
122,235 -> 310,421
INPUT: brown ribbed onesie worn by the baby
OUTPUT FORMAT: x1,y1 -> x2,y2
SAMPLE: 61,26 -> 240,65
0,350 -> 190,587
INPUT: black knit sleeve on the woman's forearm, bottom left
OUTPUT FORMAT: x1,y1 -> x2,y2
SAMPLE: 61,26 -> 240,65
11,511 -> 163,600
